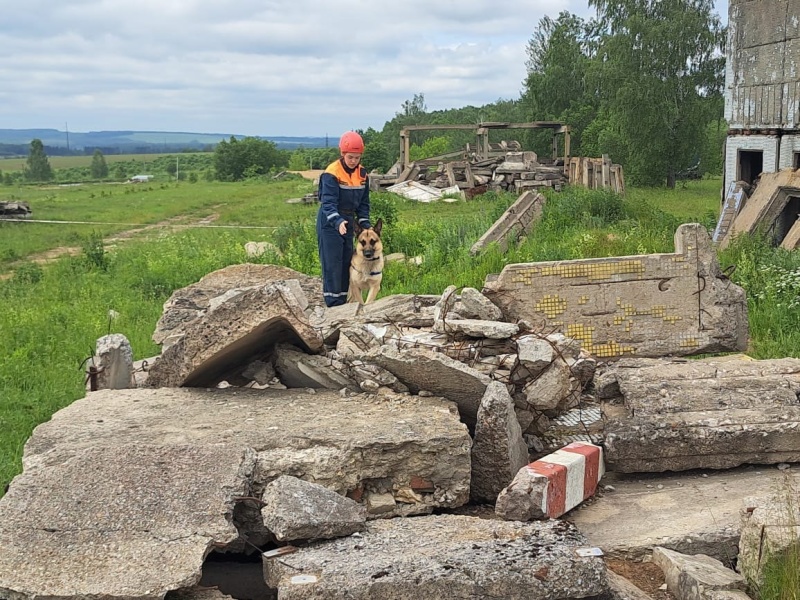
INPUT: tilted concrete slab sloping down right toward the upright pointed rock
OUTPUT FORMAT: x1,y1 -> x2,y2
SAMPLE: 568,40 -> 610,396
361,346 -> 492,426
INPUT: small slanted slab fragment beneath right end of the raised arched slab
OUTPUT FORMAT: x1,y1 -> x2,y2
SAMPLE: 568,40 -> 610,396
274,344 -> 358,391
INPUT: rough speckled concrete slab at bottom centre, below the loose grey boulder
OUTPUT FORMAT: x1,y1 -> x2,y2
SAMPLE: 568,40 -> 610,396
264,515 -> 607,600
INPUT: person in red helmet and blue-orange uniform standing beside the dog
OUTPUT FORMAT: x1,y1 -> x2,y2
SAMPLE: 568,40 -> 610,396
317,131 -> 372,306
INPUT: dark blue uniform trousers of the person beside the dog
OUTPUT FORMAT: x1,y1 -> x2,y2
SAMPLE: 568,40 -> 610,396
317,208 -> 353,306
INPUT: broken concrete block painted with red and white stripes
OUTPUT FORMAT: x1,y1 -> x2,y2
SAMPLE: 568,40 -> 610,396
495,442 -> 605,521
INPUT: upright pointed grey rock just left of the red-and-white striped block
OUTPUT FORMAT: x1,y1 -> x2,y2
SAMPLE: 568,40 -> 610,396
470,381 -> 528,503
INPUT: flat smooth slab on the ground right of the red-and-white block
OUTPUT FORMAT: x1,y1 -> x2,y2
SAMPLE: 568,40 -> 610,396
569,466 -> 800,562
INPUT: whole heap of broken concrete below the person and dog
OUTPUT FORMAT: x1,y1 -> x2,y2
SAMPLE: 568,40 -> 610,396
0,226 -> 800,600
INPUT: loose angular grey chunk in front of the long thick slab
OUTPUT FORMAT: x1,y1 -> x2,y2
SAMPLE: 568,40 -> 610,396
261,475 -> 367,542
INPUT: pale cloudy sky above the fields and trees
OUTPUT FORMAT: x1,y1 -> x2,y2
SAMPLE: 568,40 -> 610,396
0,0 -> 728,136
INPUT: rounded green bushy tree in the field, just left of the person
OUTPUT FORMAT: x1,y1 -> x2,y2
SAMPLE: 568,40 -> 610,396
214,136 -> 287,181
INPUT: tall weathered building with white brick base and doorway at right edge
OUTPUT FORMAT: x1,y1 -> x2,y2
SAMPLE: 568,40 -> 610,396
723,0 -> 800,189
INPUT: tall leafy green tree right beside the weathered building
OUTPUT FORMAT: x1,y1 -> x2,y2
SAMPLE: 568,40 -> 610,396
589,0 -> 725,187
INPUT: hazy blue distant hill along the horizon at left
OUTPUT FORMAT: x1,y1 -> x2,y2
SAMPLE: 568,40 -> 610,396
0,129 -> 336,156
